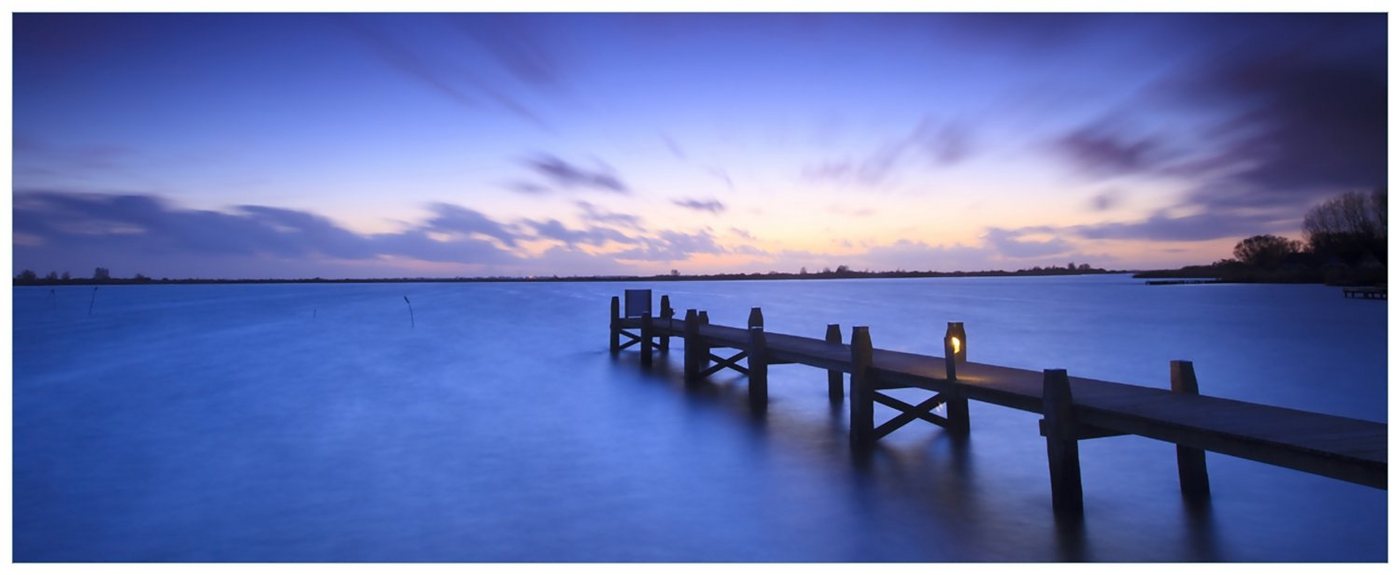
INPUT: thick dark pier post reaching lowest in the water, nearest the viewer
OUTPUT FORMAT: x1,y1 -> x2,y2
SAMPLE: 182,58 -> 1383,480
1042,369 -> 1084,518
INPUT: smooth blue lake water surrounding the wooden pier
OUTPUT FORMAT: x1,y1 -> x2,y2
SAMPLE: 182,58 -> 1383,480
13,276 -> 1387,562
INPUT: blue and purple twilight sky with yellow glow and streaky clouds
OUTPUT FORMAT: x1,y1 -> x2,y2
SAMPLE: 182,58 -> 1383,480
10,13 -> 1387,278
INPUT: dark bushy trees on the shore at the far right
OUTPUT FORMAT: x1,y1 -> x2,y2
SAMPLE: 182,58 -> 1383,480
1133,187 -> 1387,285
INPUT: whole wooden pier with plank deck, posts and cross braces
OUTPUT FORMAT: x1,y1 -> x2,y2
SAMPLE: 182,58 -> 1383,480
609,290 -> 1387,518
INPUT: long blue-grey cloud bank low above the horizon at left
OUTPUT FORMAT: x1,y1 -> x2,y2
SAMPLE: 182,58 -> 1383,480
14,190 -> 757,277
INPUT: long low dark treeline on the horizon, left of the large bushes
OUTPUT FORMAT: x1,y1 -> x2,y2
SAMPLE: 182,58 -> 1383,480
14,263 -> 1127,285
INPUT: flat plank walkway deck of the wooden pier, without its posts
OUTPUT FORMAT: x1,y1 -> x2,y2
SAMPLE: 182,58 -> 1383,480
609,303 -> 1387,488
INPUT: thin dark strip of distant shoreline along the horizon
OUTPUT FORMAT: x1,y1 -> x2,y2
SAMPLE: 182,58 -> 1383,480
14,267 -> 1134,287
